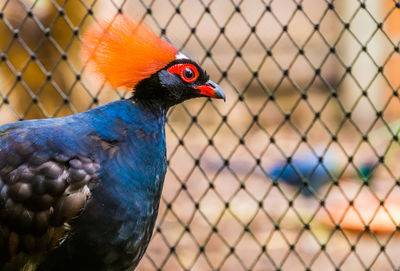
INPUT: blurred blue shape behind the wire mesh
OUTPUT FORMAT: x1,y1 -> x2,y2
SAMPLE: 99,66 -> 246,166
267,150 -> 337,197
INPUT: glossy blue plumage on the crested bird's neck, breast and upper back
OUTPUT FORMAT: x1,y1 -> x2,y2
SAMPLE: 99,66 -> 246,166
0,100 -> 166,270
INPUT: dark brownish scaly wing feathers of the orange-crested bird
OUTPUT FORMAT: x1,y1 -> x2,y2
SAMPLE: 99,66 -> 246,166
0,128 -> 99,270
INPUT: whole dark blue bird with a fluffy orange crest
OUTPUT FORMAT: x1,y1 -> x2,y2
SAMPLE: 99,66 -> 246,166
0,14 -> 225,271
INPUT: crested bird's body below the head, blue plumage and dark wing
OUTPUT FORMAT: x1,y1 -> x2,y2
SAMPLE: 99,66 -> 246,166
0,100 -> 166,270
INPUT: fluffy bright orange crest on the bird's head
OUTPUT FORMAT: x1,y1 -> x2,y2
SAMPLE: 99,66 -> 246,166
82,15 -> 178,89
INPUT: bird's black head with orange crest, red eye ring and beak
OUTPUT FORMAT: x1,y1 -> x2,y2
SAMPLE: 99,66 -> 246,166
82,15 -> 225,106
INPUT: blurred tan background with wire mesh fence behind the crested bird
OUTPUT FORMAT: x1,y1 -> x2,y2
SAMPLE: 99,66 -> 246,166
0,0 -> 400,271
